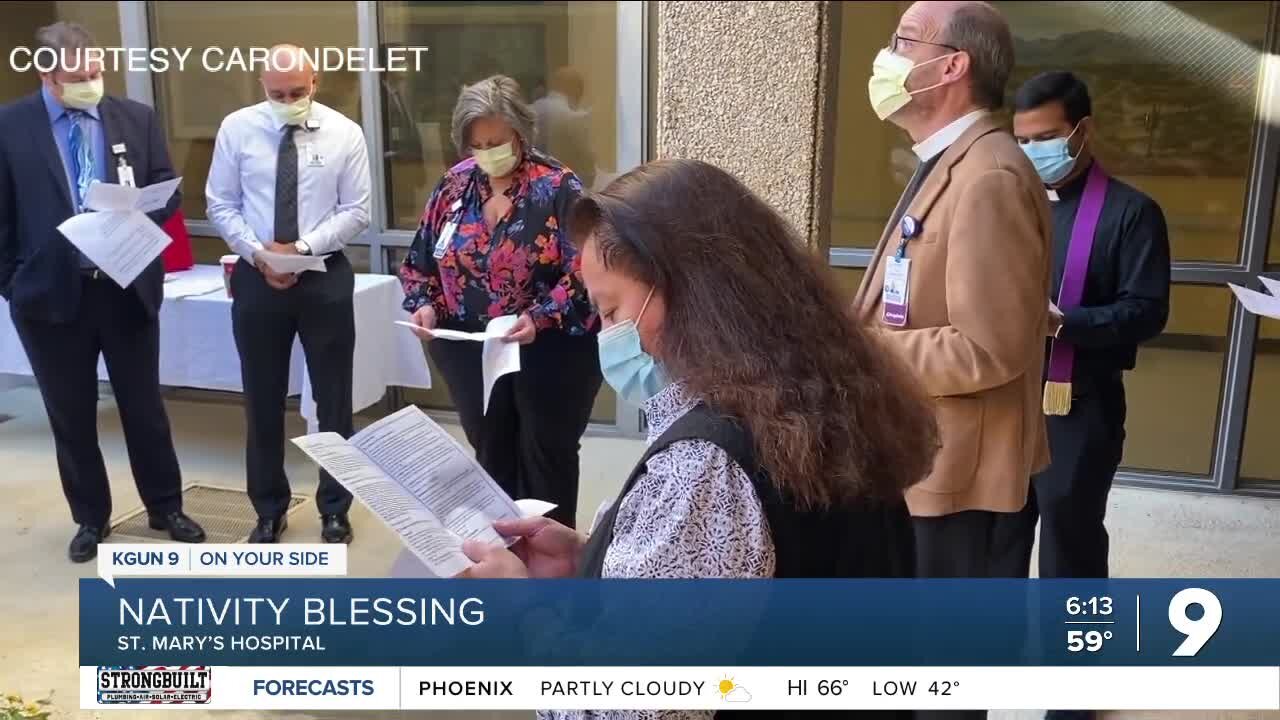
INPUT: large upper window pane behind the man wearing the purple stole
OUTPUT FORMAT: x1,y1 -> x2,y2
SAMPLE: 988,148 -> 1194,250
996,1 -> 1270,263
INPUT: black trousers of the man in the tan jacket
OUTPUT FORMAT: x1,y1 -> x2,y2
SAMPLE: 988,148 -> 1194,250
911,510 -> 1027,720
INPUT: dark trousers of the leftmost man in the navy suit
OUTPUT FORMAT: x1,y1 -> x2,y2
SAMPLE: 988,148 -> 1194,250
10,277 -> 182,528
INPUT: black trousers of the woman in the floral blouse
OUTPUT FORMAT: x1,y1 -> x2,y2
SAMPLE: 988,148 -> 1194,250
428,331 -> 603,528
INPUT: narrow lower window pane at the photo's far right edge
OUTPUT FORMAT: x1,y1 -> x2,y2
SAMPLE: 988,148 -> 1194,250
1240,318 -> 1280,482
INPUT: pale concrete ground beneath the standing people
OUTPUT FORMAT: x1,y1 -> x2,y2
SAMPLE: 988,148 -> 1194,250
0,388 -> 1280,720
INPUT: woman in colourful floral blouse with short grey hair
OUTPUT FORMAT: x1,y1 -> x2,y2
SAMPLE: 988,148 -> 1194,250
399,76 -> 602,525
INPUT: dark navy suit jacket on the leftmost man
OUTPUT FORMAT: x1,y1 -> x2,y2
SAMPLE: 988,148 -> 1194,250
0,91 -> 182,324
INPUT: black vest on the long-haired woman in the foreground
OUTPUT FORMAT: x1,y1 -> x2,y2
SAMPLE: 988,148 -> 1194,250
580,405 -> 915,578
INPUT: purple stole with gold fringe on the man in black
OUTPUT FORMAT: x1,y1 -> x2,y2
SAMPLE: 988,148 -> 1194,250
1044,159 -> 1107,415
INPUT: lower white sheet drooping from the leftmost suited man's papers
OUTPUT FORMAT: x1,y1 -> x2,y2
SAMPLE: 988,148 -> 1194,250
58,210 -> 173,287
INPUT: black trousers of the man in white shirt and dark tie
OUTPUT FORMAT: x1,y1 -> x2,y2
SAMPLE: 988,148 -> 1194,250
232,252 -> 356,518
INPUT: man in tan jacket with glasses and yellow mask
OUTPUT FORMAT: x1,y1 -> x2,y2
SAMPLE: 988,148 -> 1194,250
854,3 -> 1052,578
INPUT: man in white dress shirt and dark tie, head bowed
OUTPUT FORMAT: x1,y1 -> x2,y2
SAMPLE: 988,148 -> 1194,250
205,45 -> 370,543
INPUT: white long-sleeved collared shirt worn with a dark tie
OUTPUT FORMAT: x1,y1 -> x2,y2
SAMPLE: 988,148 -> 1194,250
205,101 -> 371,263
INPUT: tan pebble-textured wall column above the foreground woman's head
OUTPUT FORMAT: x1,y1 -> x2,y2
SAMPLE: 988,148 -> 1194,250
655,0 -> 826,242
